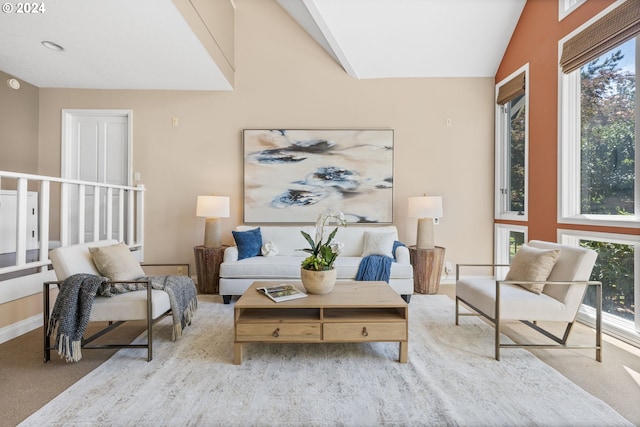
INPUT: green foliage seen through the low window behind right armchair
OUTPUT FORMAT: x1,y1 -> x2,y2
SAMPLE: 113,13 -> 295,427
580,240 -> 635,320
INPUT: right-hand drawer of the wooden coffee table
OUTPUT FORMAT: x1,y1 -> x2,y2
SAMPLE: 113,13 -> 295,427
324,322 -> 407,341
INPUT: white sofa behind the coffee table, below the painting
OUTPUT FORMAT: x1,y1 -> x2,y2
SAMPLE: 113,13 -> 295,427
220,225 -> 413,304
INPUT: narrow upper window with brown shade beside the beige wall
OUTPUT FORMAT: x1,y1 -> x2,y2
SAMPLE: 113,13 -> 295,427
495,66 -> 529,221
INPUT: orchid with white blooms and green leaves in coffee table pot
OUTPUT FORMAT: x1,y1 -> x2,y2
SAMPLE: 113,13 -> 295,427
301,211 -> 347,271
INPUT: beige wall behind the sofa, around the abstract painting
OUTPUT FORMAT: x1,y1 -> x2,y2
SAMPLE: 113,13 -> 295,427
0,0 -> 494,327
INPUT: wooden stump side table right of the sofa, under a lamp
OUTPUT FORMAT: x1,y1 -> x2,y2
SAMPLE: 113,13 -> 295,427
409,246 -> 445,294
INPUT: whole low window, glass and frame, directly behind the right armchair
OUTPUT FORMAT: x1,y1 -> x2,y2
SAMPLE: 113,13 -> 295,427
560,230 -> 640,345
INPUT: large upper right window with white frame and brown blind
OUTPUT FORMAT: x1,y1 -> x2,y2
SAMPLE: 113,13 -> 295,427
558,2 -> 640,227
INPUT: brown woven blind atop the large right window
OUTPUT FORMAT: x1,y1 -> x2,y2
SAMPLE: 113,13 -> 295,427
560,0 -> 640,74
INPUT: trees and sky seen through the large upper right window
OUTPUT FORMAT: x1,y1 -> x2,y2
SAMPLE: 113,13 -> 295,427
580,46 -> 636,215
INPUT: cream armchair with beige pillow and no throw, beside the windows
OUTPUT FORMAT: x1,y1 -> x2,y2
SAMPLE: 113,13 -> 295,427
456,240 -> 602,361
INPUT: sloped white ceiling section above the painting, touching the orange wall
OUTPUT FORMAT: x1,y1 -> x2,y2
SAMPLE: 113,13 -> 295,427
277,0 -> 526,79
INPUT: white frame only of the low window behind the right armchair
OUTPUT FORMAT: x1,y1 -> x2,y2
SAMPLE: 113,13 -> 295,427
558,229 -> 640,347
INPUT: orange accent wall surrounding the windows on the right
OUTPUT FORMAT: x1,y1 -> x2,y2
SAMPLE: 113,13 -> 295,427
495,0 -> 638,241
